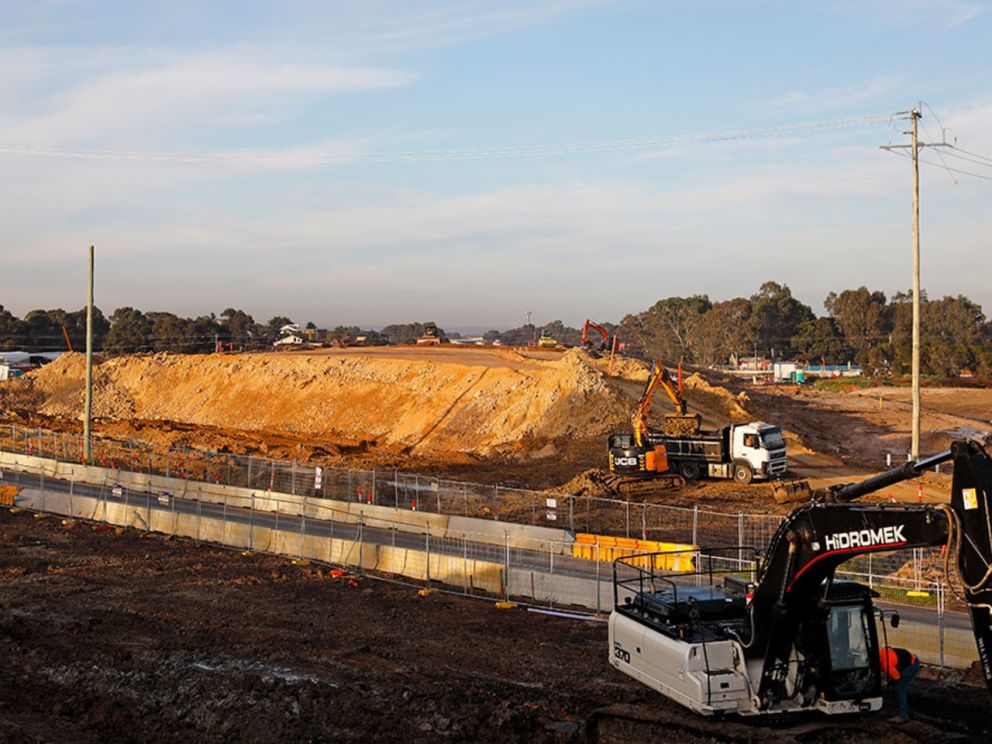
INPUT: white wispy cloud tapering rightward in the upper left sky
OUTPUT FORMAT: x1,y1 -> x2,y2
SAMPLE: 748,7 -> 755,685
0,48 -> 413,147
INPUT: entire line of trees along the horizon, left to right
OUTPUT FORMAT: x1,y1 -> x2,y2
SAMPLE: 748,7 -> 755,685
0,281 -> 992,377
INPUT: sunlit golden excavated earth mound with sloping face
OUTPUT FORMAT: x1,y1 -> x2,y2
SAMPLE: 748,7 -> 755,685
31,349 -> 629,456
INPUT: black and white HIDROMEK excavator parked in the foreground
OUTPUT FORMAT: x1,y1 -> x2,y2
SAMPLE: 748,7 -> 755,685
609,432 -> 992,716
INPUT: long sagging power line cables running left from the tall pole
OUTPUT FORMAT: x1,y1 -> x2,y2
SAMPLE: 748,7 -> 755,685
0,114 -> 892,166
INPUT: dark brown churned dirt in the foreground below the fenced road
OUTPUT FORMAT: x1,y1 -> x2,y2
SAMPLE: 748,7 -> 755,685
0,509 -> 990,744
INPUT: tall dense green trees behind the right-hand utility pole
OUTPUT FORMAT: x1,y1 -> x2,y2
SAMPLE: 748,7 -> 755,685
619,281 -> 992,377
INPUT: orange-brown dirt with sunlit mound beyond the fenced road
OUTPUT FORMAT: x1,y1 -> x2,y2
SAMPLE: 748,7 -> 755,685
0,346 -> 992,511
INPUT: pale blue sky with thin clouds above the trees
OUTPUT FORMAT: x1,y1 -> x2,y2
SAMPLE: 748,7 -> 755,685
0,0 -> 992,330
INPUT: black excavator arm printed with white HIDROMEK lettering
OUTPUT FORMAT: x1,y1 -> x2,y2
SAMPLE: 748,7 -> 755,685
745,441 -> 992,707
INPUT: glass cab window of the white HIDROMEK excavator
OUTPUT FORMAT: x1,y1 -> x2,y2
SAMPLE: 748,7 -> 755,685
824,603 -> 876,700
